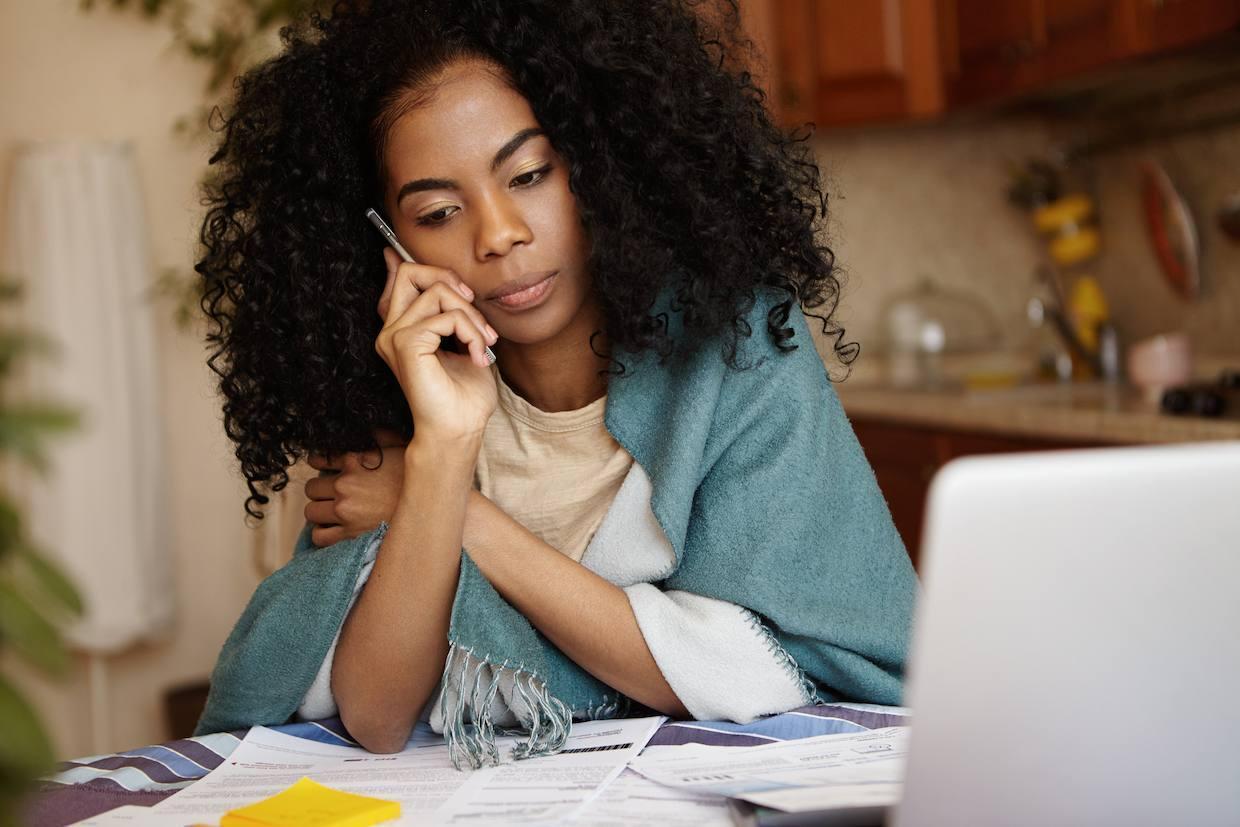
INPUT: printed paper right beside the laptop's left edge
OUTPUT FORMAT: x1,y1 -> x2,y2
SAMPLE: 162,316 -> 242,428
632,727 -> 909,812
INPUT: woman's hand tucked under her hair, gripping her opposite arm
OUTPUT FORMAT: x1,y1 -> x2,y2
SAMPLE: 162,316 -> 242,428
305,429 -> 407,548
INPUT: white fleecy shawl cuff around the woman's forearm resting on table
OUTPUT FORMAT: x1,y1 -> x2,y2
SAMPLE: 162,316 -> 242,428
625,583 -> 816,724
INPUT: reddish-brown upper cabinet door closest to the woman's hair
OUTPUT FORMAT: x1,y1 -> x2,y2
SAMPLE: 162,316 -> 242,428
751,0 -> 944,128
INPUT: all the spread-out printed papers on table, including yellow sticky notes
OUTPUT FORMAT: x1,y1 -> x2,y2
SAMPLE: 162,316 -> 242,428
79,718 -> 909,827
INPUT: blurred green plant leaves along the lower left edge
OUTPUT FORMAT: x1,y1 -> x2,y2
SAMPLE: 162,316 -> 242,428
0,274 -> 82,827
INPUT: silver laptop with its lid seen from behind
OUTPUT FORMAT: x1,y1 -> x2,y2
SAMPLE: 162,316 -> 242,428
893,443 -> 1240,827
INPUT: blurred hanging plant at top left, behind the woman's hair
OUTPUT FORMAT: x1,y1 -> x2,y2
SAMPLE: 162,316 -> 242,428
78,0 -> 331,330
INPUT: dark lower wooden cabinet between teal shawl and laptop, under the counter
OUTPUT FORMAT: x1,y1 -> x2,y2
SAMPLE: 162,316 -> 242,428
853,418 -> 1100,568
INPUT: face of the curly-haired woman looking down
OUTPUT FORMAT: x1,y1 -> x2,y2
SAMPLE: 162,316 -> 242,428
383,61 -> 591,343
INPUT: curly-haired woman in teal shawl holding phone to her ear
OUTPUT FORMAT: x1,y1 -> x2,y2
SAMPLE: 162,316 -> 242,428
190,0 -> 915,765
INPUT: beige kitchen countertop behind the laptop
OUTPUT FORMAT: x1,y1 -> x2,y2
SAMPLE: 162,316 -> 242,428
836,377 -> 1240,444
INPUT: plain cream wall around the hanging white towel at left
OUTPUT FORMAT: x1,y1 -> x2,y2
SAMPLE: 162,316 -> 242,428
0,0 -> 266,758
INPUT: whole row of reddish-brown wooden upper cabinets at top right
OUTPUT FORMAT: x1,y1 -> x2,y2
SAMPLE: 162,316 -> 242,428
742,0 -> 1240,128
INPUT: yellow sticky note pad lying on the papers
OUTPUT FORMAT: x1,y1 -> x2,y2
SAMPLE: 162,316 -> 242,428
219,779 -> 401,827
